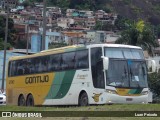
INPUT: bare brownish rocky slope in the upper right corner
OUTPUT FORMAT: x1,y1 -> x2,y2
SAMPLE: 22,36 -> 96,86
110,0 -> 160,25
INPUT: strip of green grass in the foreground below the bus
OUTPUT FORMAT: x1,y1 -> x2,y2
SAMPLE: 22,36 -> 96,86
0,104 -> 160,120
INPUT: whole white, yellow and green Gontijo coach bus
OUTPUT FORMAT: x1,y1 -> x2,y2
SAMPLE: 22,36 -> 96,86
6,44 -> 149,106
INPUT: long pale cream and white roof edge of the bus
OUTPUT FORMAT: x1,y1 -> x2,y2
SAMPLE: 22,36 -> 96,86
9,43 -> 142,60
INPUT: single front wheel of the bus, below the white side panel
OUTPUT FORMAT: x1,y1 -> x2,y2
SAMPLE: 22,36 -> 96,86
79,92 -> 88,106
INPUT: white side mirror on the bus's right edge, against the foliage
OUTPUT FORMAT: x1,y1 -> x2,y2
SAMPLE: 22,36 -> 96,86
146,59 -> 157,73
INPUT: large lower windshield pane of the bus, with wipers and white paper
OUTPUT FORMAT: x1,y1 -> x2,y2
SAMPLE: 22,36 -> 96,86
106,59 -> 148,88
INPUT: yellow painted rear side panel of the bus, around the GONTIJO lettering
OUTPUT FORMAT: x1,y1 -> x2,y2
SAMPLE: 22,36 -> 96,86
7,73 -> 55,105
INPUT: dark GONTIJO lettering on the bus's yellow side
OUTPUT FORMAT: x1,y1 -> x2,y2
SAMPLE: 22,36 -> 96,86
25,75 -> 49,84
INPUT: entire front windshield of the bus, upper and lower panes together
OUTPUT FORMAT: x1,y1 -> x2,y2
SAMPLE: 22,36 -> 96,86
105,48 -> 148,88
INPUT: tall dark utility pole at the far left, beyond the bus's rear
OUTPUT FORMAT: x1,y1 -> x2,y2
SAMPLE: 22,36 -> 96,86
1,0 -> 9,90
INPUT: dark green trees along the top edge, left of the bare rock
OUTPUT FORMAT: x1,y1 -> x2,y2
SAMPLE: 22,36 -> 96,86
34,0 -> 112,13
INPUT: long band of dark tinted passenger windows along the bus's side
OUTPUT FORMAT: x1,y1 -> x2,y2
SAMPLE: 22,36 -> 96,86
8,50 -> 88,76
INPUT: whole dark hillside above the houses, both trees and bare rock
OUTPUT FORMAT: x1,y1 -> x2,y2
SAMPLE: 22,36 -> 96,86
40,0 -> 160,25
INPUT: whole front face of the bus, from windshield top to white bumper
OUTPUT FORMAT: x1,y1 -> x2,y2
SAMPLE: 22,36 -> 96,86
102,45 -> 149,103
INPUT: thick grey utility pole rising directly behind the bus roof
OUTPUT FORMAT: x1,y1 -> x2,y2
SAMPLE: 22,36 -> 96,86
42,0 -> 47,50
